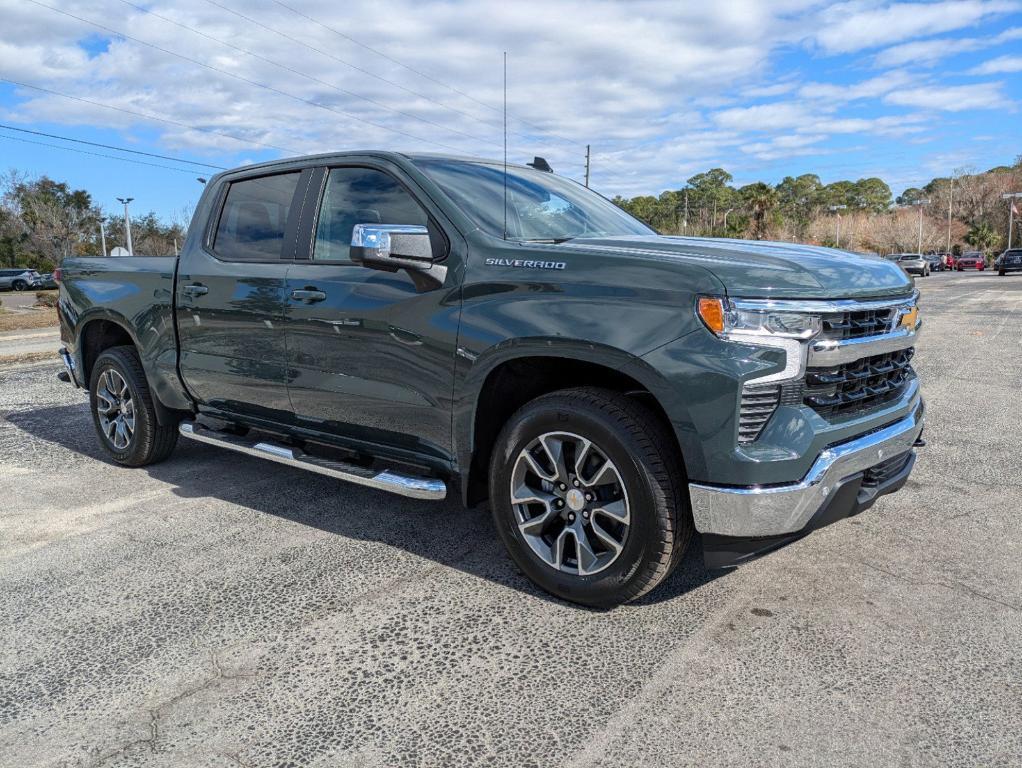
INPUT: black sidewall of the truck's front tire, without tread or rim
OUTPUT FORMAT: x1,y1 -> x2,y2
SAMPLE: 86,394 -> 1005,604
490,396 -> 666,605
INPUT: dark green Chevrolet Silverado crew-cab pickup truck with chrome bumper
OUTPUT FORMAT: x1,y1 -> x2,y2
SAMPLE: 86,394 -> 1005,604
59,151 -> 923,606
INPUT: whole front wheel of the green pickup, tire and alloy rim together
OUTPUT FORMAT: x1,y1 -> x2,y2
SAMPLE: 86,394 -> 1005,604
490,388 -> 693,607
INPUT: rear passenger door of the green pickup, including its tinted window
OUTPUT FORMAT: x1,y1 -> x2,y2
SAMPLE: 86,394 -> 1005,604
177,170 -> 312,421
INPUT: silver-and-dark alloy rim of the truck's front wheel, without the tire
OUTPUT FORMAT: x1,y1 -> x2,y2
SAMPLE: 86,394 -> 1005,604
510,432 -> 632,576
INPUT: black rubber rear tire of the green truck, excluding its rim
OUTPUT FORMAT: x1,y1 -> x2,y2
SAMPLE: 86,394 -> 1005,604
89,347 -> 178,466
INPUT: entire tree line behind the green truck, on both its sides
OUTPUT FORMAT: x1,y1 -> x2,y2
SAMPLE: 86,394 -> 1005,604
0,155 -> 1022,271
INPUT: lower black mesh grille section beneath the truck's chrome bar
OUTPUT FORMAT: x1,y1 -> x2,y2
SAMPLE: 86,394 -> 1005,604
802,349 -> 915,417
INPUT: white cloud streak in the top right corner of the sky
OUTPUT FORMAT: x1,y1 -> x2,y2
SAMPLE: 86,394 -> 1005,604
810,0 -> 1019,53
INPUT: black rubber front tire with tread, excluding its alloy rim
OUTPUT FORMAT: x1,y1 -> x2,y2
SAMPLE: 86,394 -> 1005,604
490,388 -> 693,607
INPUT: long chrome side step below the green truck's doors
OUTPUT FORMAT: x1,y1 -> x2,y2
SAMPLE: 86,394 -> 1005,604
178,421 -> 447,501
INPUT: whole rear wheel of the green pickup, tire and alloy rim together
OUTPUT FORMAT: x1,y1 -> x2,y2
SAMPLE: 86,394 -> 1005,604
89,347 -> 178,466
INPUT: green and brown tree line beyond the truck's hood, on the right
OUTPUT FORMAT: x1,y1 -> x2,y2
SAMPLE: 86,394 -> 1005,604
613,155 -> 1022,254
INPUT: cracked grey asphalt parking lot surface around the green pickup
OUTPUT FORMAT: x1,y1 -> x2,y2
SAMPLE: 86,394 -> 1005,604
0,273 -> 1022,768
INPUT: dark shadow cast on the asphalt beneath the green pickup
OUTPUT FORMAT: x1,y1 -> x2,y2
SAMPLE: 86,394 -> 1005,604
5,405 -> 724,605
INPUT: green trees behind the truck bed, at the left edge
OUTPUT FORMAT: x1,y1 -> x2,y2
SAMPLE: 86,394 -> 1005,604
0,171 -> 187,272
